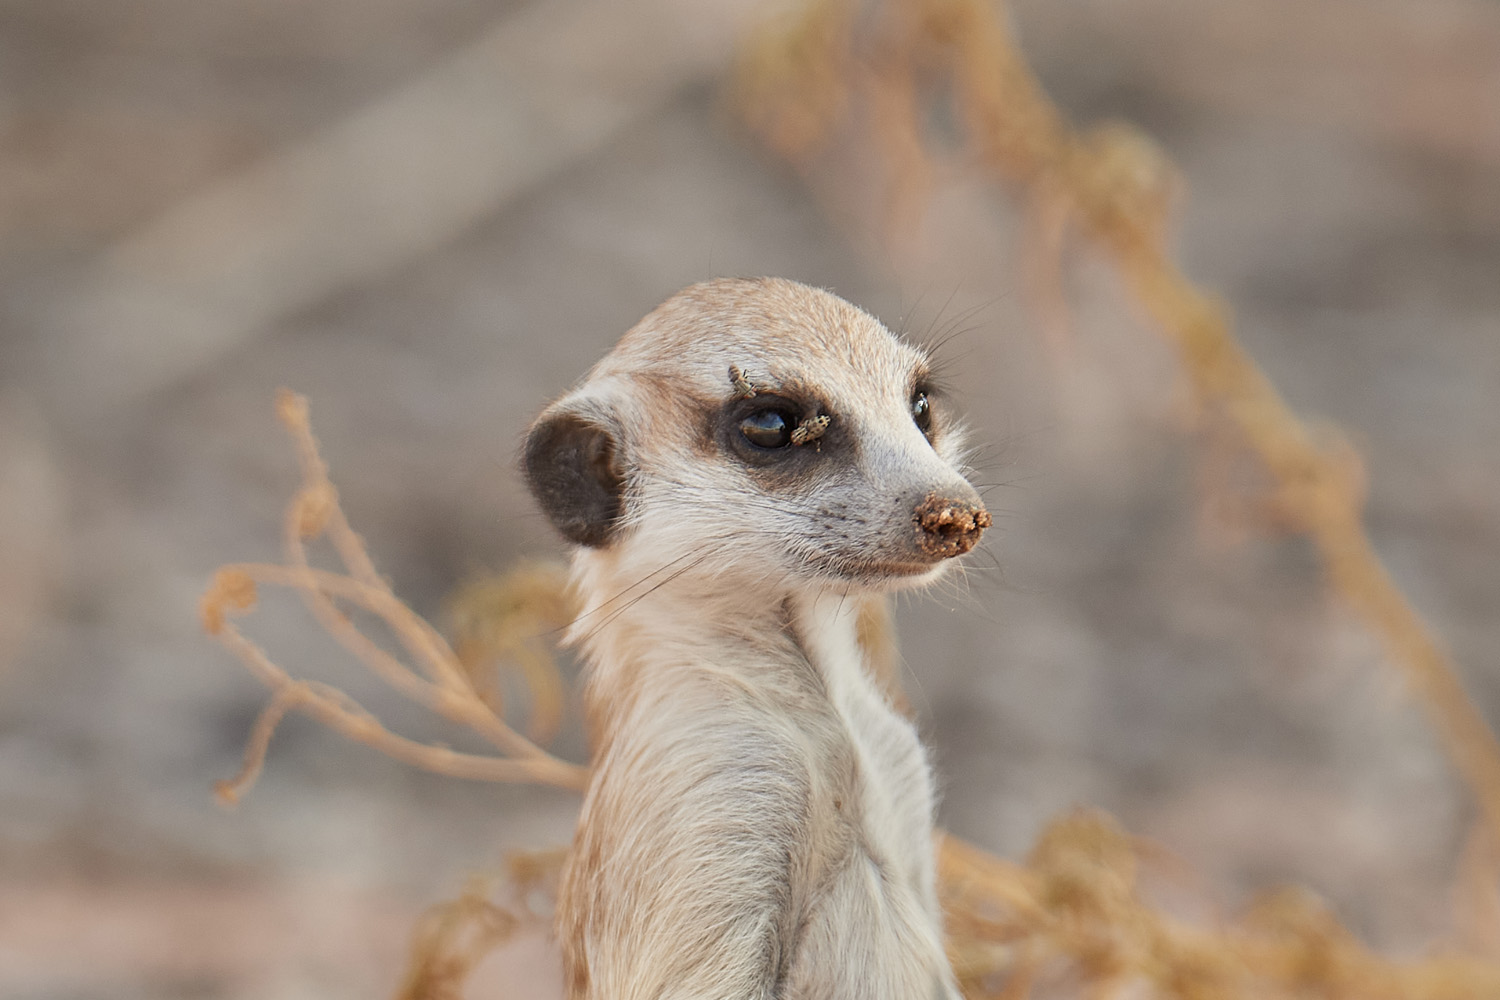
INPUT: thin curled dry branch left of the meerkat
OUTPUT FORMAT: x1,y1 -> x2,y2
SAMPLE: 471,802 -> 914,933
200,390 -> 587,804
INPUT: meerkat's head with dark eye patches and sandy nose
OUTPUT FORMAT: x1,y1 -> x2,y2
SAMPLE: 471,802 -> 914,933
524,279 -> 990,589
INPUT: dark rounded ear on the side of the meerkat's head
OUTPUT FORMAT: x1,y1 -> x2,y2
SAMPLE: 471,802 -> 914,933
522,409 -> 626,549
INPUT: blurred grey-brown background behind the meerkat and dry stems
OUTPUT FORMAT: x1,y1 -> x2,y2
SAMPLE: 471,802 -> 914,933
0,0 -> 1500,1000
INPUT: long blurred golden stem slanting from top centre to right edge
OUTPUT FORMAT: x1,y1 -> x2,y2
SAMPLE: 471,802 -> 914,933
741,0 -> 1500,843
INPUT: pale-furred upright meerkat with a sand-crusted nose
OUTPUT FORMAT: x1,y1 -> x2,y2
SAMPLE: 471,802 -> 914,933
524,279 -> 990,1000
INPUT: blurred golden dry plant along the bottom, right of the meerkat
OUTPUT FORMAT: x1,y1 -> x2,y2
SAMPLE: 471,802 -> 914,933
939,813 -> 1500,1000
